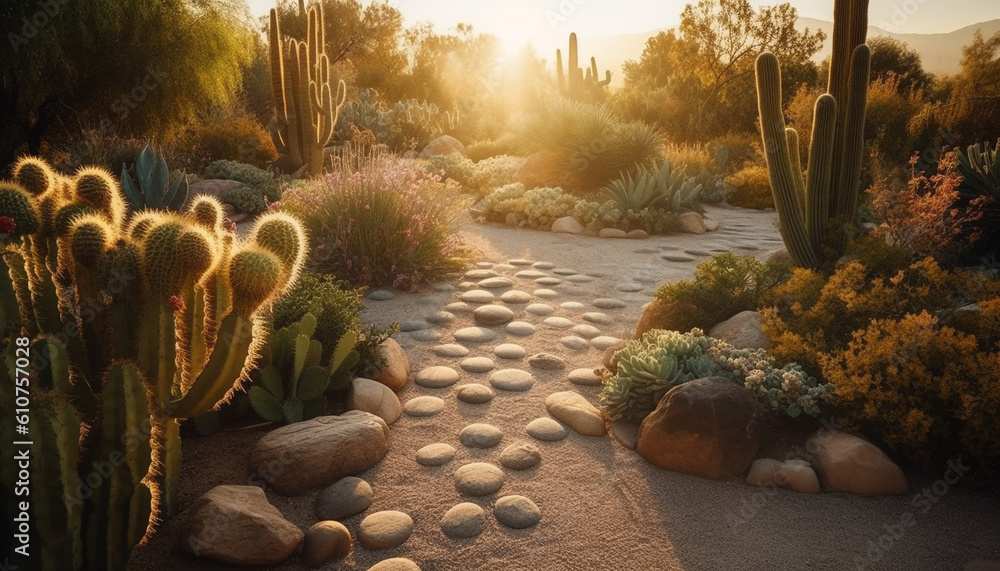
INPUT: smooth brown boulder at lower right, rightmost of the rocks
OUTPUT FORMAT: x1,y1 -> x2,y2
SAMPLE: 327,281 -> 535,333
806,430 -> 907,496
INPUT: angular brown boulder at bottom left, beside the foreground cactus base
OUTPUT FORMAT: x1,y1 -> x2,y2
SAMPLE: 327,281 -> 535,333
180,486 -> 304,565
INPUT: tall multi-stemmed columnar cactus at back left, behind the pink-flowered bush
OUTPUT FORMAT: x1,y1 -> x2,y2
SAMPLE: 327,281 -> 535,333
268,0 -> 347,175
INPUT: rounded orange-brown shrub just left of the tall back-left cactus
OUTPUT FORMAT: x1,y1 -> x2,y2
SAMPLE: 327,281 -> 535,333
170,116 -> 278,172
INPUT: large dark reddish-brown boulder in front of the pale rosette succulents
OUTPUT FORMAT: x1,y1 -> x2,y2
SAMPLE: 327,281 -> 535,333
636,377 -> 761,480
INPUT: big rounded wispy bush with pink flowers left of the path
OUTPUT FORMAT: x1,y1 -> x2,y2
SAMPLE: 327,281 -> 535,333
281,150 -> 468,289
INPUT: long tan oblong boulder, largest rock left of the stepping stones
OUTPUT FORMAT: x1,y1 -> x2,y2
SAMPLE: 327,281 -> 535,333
250,410 -> 389,496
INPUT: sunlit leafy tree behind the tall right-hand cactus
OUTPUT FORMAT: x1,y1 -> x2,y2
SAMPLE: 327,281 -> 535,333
624,0 -> 825,139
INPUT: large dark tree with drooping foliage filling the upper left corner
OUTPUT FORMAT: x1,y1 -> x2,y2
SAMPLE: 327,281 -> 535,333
0,0 -> 251,170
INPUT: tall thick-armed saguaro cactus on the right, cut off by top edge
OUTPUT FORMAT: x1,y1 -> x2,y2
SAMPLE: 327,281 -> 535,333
756,0 -> 871,268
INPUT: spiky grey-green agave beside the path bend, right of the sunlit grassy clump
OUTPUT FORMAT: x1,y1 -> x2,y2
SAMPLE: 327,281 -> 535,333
601,161 -> 701,212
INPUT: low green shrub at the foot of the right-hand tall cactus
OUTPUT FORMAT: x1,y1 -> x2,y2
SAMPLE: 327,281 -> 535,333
656,252 -> 791,331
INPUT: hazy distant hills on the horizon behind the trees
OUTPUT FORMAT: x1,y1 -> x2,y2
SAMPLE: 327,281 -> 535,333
580,18 -> 1000,87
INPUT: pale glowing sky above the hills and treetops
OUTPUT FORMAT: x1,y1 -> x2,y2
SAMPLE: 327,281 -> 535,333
247,0 -> 1000,57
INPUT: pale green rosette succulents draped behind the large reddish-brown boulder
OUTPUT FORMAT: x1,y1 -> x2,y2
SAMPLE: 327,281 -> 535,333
601,328 -> 833,423
